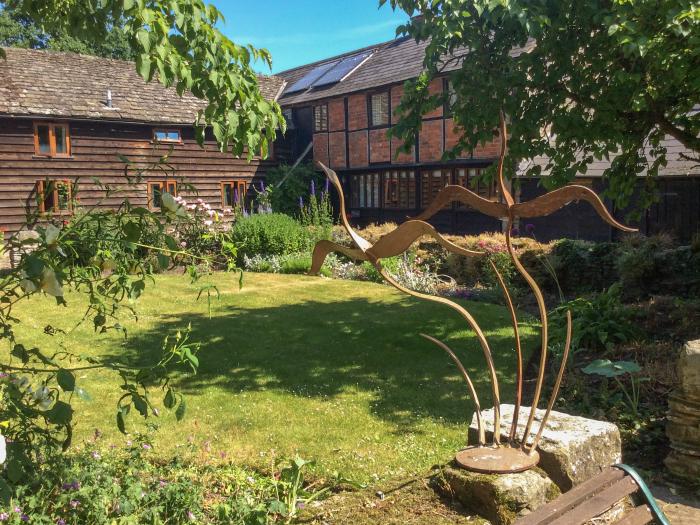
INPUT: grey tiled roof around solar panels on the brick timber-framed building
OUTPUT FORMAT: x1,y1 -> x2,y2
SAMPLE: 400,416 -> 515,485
276,37 -> 534,105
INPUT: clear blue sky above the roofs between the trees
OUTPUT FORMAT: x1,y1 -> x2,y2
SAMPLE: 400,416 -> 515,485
215,0 -> 408,73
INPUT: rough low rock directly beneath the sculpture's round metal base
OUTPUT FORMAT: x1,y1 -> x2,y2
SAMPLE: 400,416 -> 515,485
437,465 -> 559,525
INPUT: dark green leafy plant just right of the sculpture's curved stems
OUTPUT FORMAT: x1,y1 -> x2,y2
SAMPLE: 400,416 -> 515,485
551,284 -> 639,350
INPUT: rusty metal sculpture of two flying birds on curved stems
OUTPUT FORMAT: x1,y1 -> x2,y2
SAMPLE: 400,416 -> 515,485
310,115 -> 635,473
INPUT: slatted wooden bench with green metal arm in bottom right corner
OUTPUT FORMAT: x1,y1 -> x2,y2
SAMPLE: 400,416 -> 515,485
516,465 -> 670,525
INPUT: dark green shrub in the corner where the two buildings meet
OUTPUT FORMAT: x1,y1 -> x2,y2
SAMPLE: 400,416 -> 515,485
266,162 -> 325,217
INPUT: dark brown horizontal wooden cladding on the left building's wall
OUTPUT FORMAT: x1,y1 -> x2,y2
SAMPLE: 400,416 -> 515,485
0,118 -> 273,232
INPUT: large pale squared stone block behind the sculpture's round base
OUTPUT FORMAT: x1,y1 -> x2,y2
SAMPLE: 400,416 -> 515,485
469,405 -> 622,492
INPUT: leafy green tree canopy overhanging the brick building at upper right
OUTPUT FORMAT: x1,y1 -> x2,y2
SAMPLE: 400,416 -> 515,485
380,0 -> 700,203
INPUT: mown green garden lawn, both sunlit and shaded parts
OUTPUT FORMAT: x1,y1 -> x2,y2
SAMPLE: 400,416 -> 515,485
17,273 -> 537,482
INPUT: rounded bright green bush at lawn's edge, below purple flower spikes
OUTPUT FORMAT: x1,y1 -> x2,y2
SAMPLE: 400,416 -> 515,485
231,213 -> 326,259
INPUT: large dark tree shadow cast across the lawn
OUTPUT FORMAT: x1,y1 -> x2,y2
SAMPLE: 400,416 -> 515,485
115,292 -> 533,430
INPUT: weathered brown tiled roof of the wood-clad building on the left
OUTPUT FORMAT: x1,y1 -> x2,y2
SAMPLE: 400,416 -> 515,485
0,48 -> 284,124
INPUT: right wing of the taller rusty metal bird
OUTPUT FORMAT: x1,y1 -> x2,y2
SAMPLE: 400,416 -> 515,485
513,185 -> 637,232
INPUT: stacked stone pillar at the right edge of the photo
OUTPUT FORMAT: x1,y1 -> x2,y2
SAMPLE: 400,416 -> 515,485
664,340 -> 700,479
